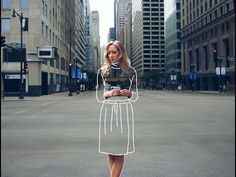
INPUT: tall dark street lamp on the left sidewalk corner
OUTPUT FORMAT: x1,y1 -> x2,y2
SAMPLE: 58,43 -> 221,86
12,9 -> 24,99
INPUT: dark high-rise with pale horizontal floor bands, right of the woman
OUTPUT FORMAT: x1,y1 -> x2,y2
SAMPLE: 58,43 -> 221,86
132,0 -> 165,75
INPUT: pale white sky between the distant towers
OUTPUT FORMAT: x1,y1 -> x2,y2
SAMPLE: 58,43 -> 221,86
89,0 -> 114,46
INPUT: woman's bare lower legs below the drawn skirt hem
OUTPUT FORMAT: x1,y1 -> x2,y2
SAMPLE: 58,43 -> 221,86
108,155 -> 124,177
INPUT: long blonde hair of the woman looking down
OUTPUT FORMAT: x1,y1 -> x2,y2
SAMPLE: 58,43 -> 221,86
103,40 -> 131,73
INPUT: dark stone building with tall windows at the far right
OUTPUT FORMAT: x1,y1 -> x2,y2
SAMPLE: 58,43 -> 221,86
181,0 -> 235,90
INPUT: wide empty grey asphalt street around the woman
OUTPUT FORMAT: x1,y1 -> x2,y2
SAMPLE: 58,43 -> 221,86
1,90 -> 235,177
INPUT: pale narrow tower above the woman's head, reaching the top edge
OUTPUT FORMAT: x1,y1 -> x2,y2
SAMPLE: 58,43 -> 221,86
114,0 -> 131,39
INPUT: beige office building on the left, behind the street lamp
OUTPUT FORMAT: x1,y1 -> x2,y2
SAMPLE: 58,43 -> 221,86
1,0 -> 85,96
